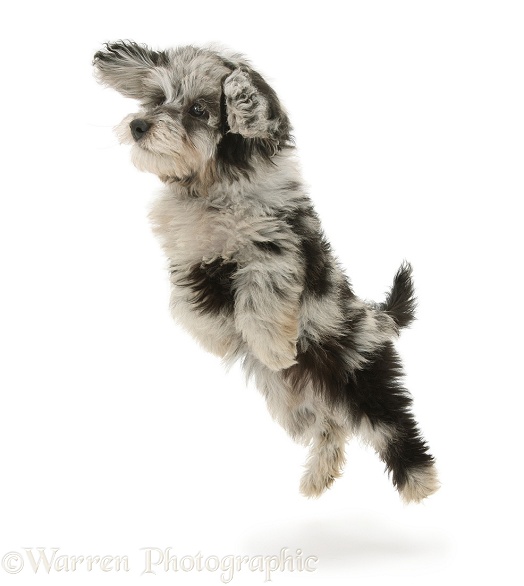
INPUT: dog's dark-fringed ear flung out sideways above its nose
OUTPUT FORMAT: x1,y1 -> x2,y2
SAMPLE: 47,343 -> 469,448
93,41 -> 168,101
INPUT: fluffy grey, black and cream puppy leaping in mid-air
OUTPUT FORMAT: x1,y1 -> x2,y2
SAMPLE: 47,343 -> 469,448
93,41 -> 439,502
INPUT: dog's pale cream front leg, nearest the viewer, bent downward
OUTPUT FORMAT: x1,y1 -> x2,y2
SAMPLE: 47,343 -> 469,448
234,252 -> 302,371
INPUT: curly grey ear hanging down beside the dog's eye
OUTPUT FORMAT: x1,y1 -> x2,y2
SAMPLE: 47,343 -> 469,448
223,65 -> 291,151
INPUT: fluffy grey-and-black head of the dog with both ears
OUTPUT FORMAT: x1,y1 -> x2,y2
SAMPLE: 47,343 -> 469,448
94,41 -> 291,186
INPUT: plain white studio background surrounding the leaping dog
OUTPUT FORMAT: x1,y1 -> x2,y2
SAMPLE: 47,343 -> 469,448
0,0 -> 524,586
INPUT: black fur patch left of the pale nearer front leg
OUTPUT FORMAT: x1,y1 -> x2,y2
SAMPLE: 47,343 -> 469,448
177,259 -> 237,314
